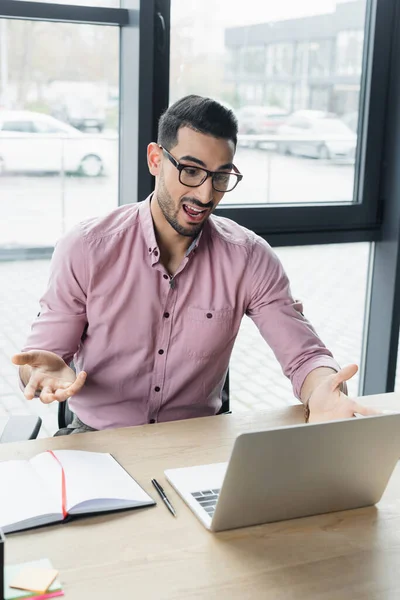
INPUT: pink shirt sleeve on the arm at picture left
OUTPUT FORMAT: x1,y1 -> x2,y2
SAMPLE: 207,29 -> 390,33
23,227 -> 88,364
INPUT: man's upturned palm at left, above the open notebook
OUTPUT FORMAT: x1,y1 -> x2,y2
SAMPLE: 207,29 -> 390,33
11,350 -> 86,404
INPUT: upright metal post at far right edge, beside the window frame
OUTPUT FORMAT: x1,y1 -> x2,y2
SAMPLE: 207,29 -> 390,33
360,0 -> 400,395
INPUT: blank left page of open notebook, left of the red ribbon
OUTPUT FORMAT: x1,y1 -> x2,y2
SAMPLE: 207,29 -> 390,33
0,460 -> 61,532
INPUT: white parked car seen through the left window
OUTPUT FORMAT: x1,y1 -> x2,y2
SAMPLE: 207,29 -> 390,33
0,110 -> 107,177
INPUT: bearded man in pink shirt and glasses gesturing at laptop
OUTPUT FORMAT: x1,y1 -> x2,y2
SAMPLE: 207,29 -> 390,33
13,96 -> 371,433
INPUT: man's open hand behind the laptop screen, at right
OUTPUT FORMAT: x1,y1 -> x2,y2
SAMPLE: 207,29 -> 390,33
308,365 -> 380,423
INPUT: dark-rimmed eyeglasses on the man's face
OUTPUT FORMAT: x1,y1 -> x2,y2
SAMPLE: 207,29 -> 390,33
160,146 -> 243,193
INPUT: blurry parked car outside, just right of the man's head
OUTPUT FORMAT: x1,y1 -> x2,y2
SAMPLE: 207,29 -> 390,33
236,106 -> 288,135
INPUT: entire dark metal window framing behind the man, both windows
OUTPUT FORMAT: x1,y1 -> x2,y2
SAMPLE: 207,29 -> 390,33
0,0 -> 400,394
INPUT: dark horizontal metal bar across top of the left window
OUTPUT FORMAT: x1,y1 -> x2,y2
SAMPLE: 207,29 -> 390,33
0,0 -> 130,26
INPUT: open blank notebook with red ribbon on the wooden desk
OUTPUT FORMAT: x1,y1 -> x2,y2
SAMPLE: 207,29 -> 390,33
0,450 -> 155,533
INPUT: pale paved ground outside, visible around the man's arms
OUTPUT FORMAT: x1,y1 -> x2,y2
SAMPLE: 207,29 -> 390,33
0,243 -> 376,437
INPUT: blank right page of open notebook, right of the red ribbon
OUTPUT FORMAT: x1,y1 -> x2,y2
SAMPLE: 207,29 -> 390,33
31,450 -> 153,512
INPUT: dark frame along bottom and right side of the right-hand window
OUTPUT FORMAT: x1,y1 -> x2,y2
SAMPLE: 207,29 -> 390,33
160,0 -> 395,245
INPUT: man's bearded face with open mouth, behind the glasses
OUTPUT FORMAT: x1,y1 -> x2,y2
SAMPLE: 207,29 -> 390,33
148,127 -> 235,237
